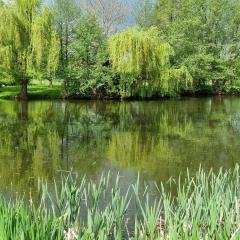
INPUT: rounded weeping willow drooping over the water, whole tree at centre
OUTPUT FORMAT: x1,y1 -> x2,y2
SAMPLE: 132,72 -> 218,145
109,27 -> 192,97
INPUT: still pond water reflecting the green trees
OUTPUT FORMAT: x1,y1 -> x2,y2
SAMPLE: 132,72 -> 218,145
0,98 -> 240,195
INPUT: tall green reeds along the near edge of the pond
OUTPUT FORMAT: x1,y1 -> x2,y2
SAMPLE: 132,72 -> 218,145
0,166 -> 240,240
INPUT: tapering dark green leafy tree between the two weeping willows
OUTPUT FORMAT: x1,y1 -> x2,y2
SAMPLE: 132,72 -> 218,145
64,15 -> 114,97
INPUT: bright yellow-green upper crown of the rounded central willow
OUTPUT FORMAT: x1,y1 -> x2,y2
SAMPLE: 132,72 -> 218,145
109,28 -> 173,74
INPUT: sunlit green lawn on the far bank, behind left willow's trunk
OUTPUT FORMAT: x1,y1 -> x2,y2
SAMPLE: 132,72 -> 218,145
0,85 -> 62,99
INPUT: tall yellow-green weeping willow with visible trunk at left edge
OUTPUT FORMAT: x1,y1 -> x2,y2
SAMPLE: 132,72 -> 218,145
0,0 -> 59,100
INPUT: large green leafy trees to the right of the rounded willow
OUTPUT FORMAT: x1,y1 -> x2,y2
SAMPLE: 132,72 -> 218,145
144,0 -> 240,92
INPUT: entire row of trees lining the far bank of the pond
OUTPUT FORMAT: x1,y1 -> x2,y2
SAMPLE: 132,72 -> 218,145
0,0 -> 240,99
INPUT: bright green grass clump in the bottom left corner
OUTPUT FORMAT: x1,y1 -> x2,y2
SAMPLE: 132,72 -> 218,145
0,197 -> 64,240
